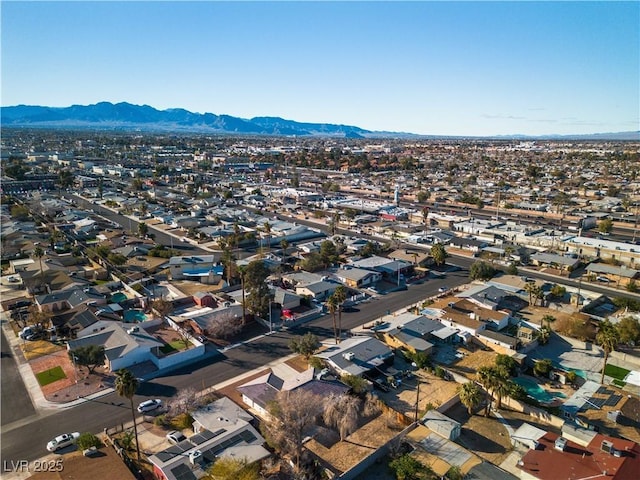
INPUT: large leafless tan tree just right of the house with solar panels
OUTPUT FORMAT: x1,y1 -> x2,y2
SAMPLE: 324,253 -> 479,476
263,389 -> 322,469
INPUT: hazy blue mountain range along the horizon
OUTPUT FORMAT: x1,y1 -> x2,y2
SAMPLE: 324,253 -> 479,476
0,102 -> 640,140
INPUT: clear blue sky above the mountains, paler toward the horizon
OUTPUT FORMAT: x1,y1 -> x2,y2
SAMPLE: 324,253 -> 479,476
1,0 -> 640,135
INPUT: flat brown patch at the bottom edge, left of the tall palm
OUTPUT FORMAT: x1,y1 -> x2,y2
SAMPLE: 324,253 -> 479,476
29,447 -> 135,480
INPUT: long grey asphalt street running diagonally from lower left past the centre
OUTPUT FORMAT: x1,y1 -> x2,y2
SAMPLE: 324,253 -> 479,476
1,270 -> 468,461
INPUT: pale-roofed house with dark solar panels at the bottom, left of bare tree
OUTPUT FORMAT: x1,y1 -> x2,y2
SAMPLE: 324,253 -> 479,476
149,397 -> 270,480
